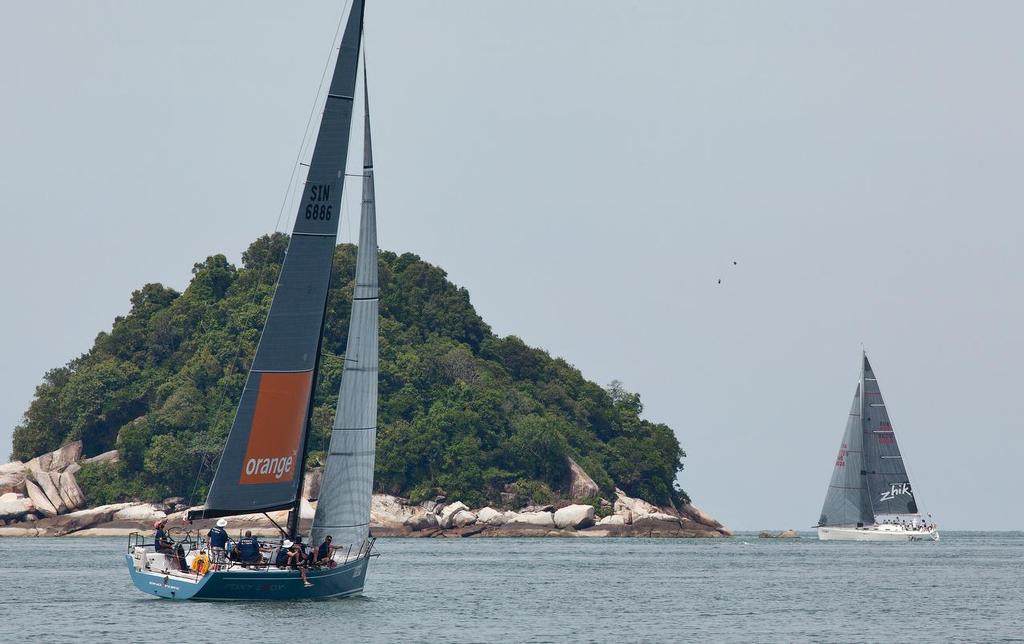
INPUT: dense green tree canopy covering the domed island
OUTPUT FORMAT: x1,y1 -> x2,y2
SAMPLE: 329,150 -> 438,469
12,233 -> 687,505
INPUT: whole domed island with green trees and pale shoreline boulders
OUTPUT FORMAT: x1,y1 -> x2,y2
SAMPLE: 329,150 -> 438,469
8,233 -> 729,536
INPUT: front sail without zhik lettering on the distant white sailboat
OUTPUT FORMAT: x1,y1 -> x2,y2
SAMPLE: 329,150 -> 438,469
818,383 -> 874,525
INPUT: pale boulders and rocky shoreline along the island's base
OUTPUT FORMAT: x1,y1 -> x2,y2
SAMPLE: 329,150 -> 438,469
0,442 -> 732,539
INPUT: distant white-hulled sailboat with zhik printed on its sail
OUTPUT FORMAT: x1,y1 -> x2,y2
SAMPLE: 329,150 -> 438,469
818,354 -> 939,542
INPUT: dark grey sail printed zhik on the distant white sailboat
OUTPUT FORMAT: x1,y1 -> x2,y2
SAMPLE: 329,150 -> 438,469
863,355 -> 918,515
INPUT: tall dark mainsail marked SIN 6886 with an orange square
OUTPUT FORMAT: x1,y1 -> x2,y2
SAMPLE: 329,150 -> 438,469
189,0 -> 362,518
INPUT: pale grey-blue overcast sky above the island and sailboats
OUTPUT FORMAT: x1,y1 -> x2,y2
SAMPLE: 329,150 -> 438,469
0,0 -> 1024,529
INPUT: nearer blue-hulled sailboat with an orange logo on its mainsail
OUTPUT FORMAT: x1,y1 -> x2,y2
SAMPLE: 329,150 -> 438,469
127,0 -> 378,600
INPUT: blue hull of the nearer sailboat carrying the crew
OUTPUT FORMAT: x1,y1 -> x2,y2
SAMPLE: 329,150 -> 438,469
125,555 -> 370,601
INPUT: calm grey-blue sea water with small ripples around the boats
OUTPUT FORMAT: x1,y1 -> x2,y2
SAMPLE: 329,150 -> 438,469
0,532 -> 1024,642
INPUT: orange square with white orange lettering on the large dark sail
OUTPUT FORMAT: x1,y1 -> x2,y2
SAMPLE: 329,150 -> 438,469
239,372 -> 312,485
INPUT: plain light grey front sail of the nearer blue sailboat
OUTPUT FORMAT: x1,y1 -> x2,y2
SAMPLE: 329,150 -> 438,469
310,74 -> 378,547
